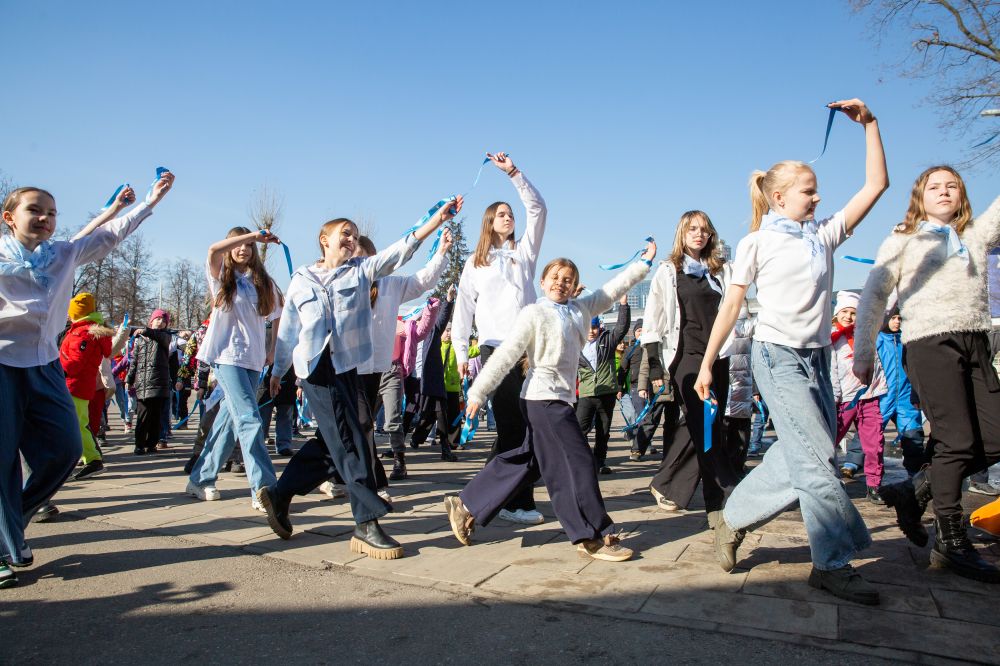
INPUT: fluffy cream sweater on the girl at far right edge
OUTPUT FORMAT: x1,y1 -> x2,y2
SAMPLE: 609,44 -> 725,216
854,197 -> 1000,363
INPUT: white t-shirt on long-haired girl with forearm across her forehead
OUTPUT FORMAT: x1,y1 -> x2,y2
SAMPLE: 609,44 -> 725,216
198,265 -> 281,371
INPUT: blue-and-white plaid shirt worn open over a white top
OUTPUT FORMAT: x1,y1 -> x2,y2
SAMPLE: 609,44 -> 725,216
273,233 -> 420,379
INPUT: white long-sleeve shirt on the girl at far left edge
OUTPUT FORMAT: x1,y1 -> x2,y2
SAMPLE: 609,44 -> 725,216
0,203 -> 153,368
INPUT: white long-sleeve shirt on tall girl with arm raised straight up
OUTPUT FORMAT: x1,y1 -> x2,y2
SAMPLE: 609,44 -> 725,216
451,171 -> 546,365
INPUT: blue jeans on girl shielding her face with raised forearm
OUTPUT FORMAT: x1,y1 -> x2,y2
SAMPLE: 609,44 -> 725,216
191,363 -> 277,496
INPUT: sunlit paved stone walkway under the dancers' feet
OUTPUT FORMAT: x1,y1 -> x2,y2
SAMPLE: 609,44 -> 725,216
43,412 -> 1000,663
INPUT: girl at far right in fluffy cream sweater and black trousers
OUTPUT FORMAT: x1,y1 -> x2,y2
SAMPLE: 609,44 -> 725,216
854,166 -> 1000,583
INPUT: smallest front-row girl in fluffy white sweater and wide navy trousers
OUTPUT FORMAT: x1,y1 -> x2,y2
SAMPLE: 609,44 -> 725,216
445,243 -> 656,562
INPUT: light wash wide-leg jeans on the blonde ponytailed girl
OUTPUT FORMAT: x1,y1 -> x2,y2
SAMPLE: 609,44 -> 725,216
723,340 -> 871,571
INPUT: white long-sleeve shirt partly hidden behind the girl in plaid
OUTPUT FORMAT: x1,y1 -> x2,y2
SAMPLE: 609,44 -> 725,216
358,252 -> 448,375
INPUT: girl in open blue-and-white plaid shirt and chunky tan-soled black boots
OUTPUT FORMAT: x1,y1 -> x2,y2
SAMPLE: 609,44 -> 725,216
257,197 -> 462,560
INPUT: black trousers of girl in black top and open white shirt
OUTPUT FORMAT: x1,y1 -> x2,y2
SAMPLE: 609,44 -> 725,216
651,354 -> 742,511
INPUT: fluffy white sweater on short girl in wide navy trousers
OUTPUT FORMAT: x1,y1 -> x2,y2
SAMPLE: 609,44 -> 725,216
469,261 -> 649,404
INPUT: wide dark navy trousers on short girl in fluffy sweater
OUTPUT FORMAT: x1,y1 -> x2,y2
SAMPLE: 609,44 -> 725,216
461,400 -> 614,543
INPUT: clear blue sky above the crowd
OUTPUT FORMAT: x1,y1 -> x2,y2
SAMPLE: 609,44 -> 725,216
0,0 -> 998,287
